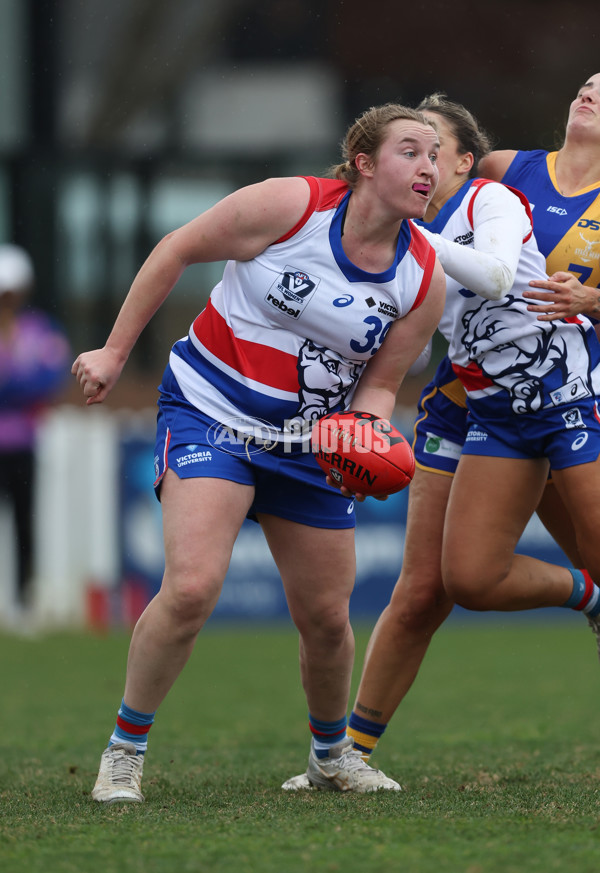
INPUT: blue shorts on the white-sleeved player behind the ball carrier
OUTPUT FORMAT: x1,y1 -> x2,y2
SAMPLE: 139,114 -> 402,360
463,394 -> 600,470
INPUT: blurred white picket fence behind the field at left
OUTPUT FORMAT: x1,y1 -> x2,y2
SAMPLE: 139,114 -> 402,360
0,406 -> 126,627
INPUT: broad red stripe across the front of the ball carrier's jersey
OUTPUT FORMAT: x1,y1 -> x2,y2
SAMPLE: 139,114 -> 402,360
192,300 -> 300,394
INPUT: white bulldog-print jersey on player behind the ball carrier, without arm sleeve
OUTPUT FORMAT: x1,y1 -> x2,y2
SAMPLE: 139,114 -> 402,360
427,179 -> 600,413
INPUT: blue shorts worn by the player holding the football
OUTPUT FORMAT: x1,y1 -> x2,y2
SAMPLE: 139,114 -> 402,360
154,392 -> 355,529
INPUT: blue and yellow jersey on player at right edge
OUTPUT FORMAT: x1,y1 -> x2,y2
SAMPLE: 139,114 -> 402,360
502,149 -> 600,288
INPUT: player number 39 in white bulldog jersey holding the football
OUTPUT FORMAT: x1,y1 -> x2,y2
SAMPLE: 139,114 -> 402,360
73,104 -> 445,803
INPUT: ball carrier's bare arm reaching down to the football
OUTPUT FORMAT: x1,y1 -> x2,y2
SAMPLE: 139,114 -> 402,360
350,259 -> 446,420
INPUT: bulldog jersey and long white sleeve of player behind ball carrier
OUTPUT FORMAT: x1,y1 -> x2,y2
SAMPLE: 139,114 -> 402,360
425,180 -> 600,430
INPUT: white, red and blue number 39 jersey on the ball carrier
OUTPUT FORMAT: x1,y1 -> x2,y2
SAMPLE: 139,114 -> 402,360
169,177 -> 435,442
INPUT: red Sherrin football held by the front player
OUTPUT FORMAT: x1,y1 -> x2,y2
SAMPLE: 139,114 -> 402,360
312,411 -> 415,497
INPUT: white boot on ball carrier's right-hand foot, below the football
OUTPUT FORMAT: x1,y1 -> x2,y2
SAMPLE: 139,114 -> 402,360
281,737 -> 402,794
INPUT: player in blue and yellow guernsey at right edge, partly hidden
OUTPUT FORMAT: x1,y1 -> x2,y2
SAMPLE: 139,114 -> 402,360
340,80 -> 600,776
